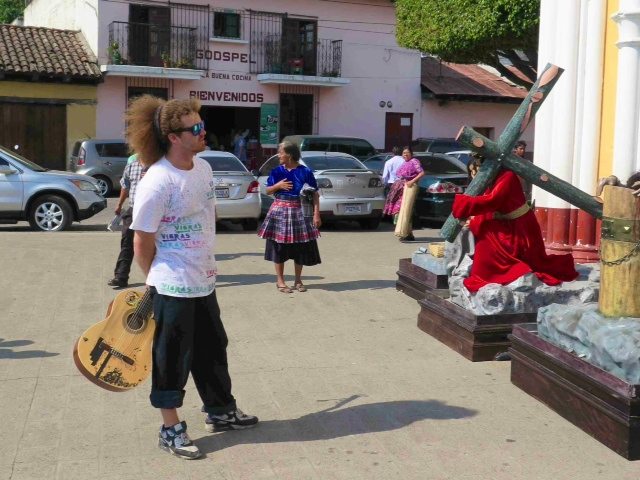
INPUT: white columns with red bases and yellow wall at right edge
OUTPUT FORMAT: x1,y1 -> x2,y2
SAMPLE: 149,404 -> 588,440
534,0 -> 640,260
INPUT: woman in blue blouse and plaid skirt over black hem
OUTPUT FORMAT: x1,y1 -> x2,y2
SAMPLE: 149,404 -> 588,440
258,142 -> 322,293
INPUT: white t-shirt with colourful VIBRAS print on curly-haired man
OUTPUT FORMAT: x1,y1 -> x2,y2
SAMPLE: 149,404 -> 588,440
130,157 -> 217,297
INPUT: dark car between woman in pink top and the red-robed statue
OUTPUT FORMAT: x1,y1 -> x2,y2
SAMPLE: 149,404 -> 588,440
414,153 -> 469,226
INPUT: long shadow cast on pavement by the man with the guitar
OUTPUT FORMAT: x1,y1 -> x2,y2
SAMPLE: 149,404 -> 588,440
196,396 -> 477,453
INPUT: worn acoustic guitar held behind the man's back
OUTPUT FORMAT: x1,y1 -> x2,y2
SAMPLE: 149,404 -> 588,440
73,289 -> 156,392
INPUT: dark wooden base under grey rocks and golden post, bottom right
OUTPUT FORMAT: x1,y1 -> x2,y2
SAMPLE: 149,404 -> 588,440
509,323 -> 640,460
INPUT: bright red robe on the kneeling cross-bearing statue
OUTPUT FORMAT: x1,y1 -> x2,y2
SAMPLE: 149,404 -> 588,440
453,170 -> 578,292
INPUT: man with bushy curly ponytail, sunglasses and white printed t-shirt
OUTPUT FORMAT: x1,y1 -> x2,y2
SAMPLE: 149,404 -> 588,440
126,95 -> 258,459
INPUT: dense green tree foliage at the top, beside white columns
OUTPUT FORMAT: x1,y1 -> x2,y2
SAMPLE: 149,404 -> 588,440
396,0 -> 540,64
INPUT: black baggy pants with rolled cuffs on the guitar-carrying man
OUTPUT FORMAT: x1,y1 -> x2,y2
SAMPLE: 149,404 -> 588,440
150,291 -> 236,414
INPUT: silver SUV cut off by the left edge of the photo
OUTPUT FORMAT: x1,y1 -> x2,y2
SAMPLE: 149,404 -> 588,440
0,143 -> 107,232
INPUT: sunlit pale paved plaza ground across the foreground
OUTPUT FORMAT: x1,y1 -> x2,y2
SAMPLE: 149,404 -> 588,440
0,199 -> 640,480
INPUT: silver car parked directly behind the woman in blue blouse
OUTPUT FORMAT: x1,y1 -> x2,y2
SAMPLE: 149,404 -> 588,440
256,151 -> 384,230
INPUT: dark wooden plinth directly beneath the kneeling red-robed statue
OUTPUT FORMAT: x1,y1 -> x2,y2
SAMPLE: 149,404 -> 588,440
418,291 -> 537,362
